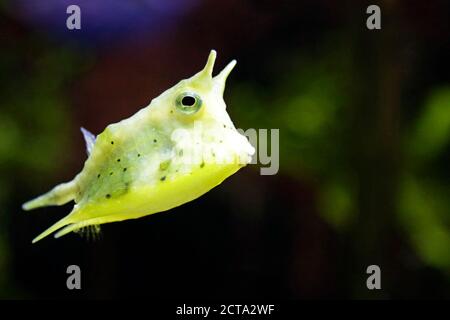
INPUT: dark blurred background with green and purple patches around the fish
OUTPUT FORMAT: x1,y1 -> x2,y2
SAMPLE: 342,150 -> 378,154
0,0 -> 450,299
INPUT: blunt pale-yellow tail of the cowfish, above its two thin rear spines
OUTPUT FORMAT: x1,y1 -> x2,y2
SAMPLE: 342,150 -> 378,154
22,179 -> 77,211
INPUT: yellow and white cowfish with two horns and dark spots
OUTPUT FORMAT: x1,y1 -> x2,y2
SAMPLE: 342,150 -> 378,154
23,50 -> 255,243
